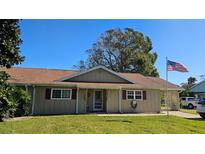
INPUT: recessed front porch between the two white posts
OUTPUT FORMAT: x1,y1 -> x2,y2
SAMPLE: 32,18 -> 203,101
76,88 -> 121,113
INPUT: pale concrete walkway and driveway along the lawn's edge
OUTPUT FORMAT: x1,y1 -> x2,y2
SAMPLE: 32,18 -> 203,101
97,111 -> 200,119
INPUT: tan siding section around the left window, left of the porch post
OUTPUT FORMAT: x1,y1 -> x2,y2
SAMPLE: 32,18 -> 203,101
34,87 -> 76,114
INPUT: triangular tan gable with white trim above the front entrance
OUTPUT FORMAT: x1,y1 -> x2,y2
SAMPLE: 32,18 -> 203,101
58,66 -> 134,83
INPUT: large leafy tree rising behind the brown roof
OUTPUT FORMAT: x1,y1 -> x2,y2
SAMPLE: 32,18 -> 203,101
75,28 -> 159,76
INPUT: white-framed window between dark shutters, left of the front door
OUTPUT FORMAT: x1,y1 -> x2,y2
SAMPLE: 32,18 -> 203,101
51,89 -> 71,99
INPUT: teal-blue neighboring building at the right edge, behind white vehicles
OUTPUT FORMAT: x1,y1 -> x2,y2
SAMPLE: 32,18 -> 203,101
190,81 -> 205,98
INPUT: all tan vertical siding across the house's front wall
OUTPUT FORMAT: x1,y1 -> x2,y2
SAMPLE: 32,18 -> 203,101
34,87 -> 162,114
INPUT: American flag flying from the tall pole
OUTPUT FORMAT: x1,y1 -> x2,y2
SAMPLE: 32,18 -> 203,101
167,60 -> 188,72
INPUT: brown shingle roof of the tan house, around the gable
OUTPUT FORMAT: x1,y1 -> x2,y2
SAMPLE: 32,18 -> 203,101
4,67 -> 182,90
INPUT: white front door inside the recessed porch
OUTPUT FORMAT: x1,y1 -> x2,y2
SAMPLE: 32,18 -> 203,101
93,90 -> 103,111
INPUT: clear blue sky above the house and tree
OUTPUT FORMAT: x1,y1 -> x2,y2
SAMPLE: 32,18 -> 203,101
18,19 -> 205,84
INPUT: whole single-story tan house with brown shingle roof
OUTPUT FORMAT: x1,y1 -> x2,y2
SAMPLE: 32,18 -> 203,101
5,66 -> 182,115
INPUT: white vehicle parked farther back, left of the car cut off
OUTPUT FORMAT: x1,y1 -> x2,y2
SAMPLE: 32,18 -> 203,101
180,97 -> 198,109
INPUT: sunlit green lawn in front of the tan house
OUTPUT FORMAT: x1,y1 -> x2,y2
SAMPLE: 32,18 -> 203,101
0,115 -> 205,134
